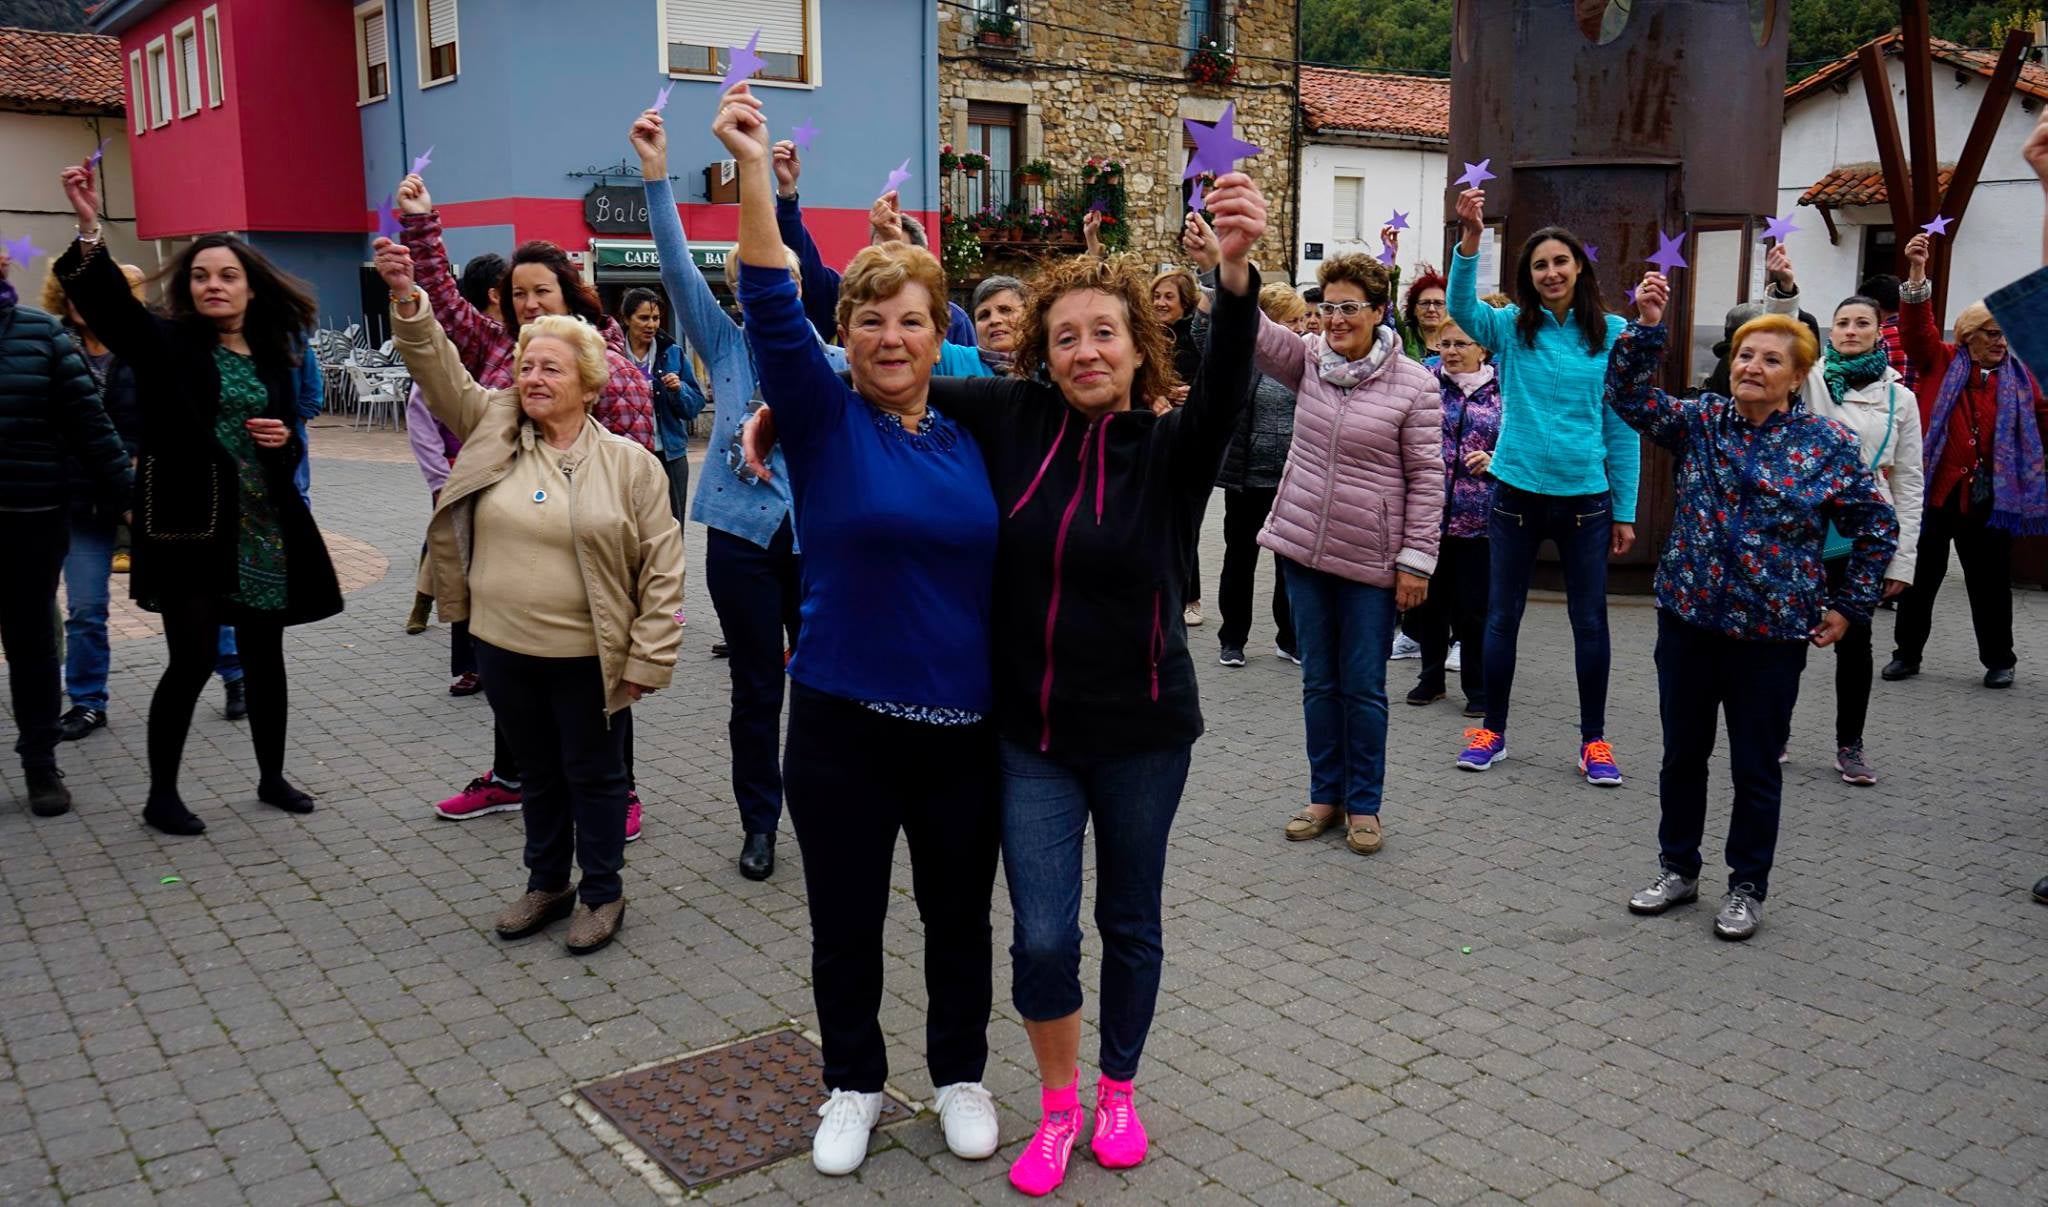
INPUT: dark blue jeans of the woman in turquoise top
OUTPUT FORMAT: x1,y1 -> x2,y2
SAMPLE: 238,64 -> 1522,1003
1487,482 -> 1614,742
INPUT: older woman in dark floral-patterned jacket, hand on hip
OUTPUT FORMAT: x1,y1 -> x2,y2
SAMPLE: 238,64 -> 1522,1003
1608,273 -> 1898,939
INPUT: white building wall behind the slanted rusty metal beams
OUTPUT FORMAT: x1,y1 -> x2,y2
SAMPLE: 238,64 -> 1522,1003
1778,59 -> 2042,322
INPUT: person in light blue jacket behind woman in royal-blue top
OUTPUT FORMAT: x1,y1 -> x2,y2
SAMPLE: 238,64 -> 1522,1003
631,111 -> 844,879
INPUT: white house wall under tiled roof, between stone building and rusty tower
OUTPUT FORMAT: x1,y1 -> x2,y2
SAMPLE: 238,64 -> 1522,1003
1294,141 -> 1450,287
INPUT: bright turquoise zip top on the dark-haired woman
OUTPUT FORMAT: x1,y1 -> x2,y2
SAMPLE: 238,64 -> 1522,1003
1446,252 -> 1642,525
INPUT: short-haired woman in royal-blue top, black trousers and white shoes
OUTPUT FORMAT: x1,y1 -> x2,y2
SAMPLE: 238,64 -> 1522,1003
713,84 -> 997,1174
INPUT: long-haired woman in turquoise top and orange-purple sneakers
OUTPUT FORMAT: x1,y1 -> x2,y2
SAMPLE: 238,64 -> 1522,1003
1450,189 -> 1642,787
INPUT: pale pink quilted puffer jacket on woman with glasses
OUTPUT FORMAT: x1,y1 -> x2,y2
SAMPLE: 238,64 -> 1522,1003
1260,318 -> 1444,586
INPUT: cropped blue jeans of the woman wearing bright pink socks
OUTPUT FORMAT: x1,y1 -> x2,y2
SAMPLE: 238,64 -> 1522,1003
1001,738 -> 1192,1082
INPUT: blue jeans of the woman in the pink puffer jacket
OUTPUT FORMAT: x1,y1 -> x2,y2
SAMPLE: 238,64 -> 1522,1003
1280,557 -> 1395,818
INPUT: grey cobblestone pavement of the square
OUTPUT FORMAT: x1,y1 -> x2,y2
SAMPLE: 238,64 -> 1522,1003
0,432 -> 2048,1207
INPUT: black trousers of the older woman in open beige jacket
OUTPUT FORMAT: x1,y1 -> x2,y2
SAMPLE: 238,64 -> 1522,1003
477,641 -> 633,908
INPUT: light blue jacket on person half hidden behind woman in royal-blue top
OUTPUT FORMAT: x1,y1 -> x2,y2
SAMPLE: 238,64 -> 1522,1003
643,176 -> 844,549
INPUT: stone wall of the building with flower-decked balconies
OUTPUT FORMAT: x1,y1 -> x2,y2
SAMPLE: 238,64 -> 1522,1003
938,0 -> 1296,279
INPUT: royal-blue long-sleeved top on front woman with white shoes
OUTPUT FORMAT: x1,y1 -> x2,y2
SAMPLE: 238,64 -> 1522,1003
739,264 -> 995,713
